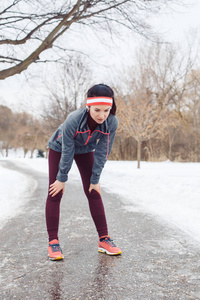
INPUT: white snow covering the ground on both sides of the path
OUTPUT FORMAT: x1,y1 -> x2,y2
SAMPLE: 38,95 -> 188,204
0,149 -> 200,242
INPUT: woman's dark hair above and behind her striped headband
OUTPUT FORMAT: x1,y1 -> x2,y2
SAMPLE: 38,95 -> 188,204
87,83 -> 117,115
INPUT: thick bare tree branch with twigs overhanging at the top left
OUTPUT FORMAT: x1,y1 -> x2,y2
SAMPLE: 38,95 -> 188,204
0,0 -> 175,79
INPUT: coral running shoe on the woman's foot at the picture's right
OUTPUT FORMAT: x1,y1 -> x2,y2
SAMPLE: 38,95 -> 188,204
98,235 -> 122,255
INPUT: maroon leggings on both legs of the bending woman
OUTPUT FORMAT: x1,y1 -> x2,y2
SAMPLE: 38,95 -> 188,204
46,149 -> 108,241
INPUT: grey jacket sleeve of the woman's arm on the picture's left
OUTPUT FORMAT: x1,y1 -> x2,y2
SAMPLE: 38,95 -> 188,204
56,115 -> 77,182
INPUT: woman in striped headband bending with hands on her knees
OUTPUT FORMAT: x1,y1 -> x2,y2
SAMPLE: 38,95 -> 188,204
46,84 -> 121,260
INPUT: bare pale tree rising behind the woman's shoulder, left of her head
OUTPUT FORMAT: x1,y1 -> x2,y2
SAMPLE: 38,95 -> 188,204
41,55 -> 92,132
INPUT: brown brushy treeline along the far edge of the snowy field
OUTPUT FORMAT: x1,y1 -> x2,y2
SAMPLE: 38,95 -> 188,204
0,94 -> 200,162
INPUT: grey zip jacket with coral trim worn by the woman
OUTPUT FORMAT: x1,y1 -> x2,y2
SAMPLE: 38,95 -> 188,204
48,108 -> 118,184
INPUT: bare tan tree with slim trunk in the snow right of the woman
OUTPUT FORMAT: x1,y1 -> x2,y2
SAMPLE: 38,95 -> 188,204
115,39 -> 199,160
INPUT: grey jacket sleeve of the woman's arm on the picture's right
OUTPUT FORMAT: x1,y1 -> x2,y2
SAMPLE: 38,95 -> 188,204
90,117 -> 118,184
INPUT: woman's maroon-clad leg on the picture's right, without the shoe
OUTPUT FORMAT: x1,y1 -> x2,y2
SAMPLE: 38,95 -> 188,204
74,152 -> 108,237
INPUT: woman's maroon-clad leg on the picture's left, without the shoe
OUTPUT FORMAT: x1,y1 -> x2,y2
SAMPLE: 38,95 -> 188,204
46,149 -> 62,241
